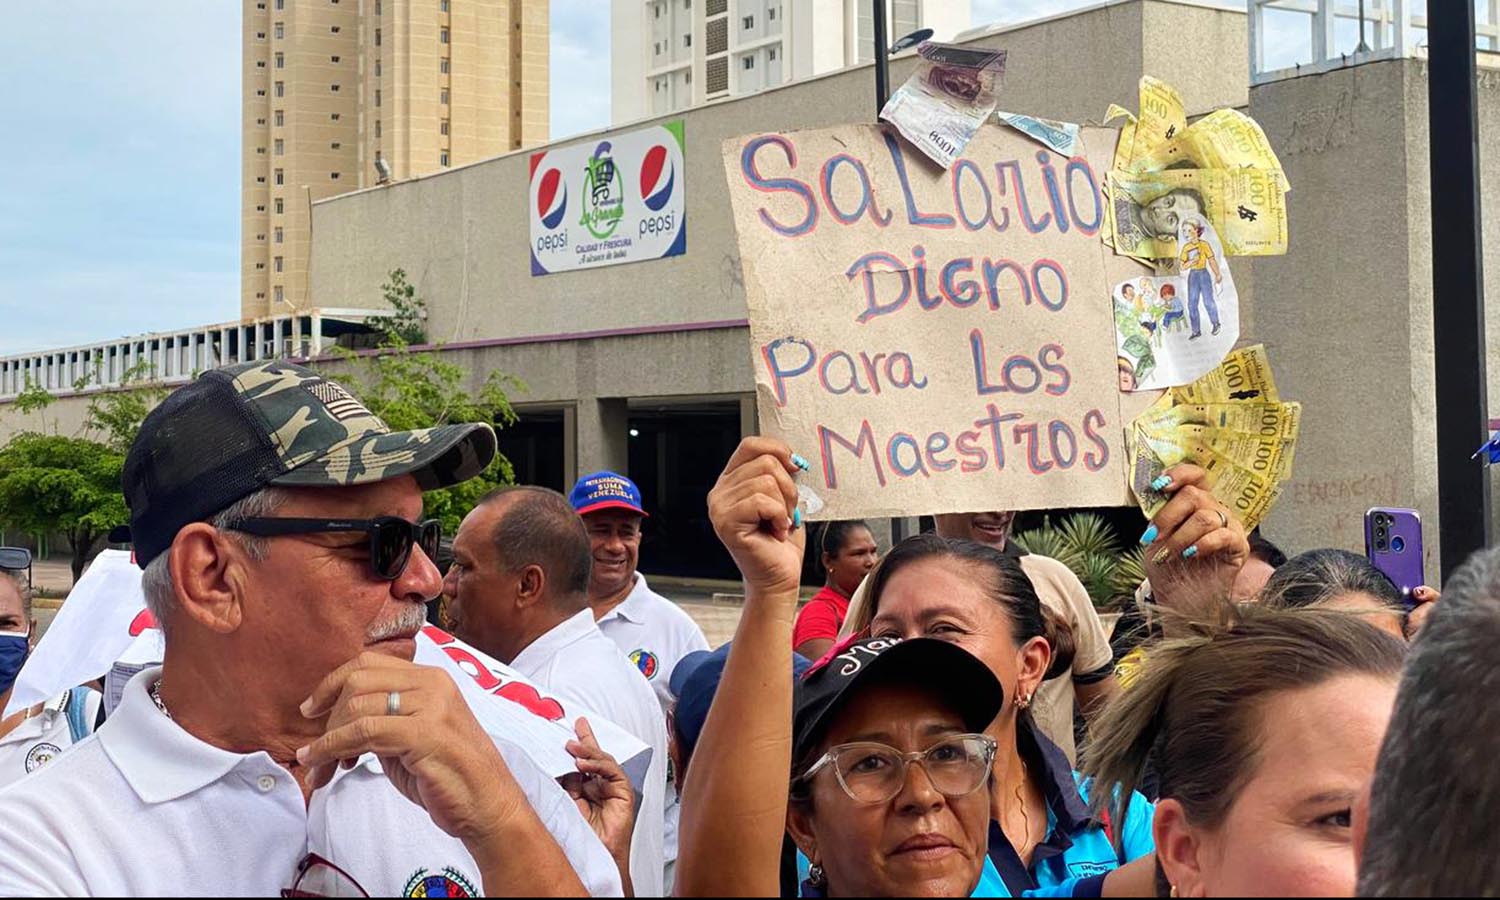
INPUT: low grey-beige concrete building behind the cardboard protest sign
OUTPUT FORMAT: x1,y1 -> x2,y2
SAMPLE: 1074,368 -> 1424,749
11,0 -> 1500,573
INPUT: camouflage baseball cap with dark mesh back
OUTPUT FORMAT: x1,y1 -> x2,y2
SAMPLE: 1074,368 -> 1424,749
122,362 -> 497,569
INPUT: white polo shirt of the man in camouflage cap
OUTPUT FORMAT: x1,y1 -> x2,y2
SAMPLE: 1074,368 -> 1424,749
0,668 -> 621,897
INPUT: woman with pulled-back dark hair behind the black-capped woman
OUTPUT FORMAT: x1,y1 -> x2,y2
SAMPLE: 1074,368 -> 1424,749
870,534 -> 1155,897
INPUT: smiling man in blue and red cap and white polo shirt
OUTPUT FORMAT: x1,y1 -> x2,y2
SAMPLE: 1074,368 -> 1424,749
569,473 -> 708,713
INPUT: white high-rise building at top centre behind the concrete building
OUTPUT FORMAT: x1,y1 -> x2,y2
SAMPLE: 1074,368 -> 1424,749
611,0 -> 969,125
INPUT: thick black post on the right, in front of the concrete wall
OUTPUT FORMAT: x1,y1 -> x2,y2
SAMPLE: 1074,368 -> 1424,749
1428,2 -> 1490,579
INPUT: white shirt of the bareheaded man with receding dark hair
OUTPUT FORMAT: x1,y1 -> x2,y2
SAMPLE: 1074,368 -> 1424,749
510,608 -> 666,897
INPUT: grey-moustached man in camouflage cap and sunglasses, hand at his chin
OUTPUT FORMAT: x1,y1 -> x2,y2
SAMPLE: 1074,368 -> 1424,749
0,363 -> 621,897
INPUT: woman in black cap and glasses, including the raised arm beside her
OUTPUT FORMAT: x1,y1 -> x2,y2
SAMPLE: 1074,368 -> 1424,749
677,438 -> 1149,897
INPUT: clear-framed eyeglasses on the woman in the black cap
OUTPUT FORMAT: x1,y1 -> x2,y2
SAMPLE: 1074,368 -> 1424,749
798,735 -> 998,804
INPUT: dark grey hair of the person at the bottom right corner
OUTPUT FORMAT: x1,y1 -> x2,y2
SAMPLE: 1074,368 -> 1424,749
1359,551 -> 1500,897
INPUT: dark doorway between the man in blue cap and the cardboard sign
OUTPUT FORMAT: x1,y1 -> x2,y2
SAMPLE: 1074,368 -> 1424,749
630,402 -> 740,579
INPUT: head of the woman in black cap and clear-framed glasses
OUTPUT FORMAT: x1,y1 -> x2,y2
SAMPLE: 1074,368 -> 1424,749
786,639 -> 1004,897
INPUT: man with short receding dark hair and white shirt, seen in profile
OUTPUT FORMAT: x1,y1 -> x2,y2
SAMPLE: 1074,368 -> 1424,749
443,488 -> 666,897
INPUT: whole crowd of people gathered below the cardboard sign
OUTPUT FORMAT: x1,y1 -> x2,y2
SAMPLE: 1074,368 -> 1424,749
0,362 -> 1500,897
